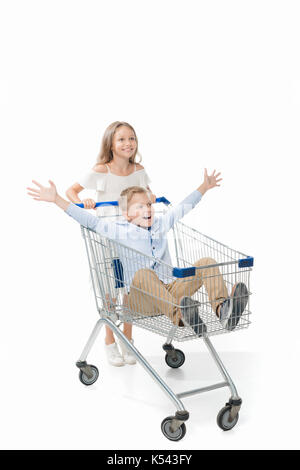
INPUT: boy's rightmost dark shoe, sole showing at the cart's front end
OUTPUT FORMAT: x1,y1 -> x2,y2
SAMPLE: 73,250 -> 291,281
218,282 -> 249,331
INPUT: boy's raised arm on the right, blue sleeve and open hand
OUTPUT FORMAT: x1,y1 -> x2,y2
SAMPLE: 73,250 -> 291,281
163,168 -> 222,231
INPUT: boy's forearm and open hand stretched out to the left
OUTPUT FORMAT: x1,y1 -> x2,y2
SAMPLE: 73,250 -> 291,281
27,180 -> 100,230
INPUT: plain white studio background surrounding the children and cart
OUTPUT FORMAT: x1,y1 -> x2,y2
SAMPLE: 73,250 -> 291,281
0,0 -> 300,449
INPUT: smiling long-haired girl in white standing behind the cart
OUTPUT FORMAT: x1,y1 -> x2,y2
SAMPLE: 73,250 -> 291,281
66,121 -> 156,366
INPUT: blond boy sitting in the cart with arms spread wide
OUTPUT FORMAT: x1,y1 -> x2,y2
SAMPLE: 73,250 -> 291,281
27,169 -> 248,336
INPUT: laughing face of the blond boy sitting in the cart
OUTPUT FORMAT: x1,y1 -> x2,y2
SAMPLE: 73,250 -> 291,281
123,193 -> 154,228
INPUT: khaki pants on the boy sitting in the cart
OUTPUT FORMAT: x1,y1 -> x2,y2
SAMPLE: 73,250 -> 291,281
128,258 -> 228,325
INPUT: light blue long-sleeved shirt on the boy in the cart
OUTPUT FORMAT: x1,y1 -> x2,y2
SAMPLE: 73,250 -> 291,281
66,190 -> 202,289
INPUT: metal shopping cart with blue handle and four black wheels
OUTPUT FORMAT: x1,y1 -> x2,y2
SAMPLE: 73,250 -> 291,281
76,198 -> 253,441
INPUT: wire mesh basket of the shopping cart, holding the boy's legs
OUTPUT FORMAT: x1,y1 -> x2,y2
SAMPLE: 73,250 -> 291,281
81,217 -> 251,341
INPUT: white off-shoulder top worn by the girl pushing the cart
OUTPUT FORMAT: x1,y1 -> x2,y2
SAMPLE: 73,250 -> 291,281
77,165 -> 151,216
